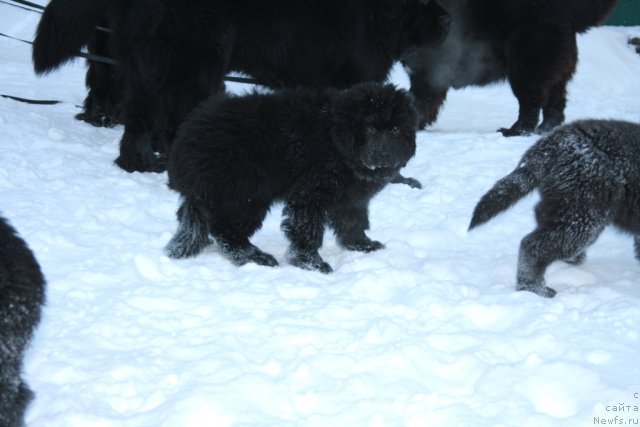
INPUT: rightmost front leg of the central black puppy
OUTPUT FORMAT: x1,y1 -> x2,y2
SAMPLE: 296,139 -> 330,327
329,203 -> 384,252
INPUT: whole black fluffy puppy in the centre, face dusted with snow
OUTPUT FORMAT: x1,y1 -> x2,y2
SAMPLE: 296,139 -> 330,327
166,83 -> 418,273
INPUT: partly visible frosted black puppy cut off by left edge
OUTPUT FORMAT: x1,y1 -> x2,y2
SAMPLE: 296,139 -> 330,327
0,217 -> 45,427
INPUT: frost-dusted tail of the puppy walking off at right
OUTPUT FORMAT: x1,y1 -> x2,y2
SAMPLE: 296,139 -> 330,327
469,162 -> 538,230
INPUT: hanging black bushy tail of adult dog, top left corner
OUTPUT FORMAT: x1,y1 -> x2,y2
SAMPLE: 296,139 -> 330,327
32,0 -> 111,74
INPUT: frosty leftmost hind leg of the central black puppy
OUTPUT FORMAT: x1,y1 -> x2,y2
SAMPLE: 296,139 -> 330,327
165,198 -> 210,258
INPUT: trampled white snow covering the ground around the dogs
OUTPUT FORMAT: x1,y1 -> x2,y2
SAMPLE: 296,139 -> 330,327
0,5 -> 640,427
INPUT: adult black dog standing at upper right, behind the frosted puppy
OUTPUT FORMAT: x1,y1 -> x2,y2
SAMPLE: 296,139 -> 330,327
403,0 -> 617,136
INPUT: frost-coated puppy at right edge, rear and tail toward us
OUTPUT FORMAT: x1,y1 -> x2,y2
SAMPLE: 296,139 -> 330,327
469,120 -> 640,297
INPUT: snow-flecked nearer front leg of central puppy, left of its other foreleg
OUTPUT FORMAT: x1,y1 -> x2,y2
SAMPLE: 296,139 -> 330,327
282,195 -> 333,273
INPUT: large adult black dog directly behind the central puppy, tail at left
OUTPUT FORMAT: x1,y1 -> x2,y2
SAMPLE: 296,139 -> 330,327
33,0 -> 450,171
